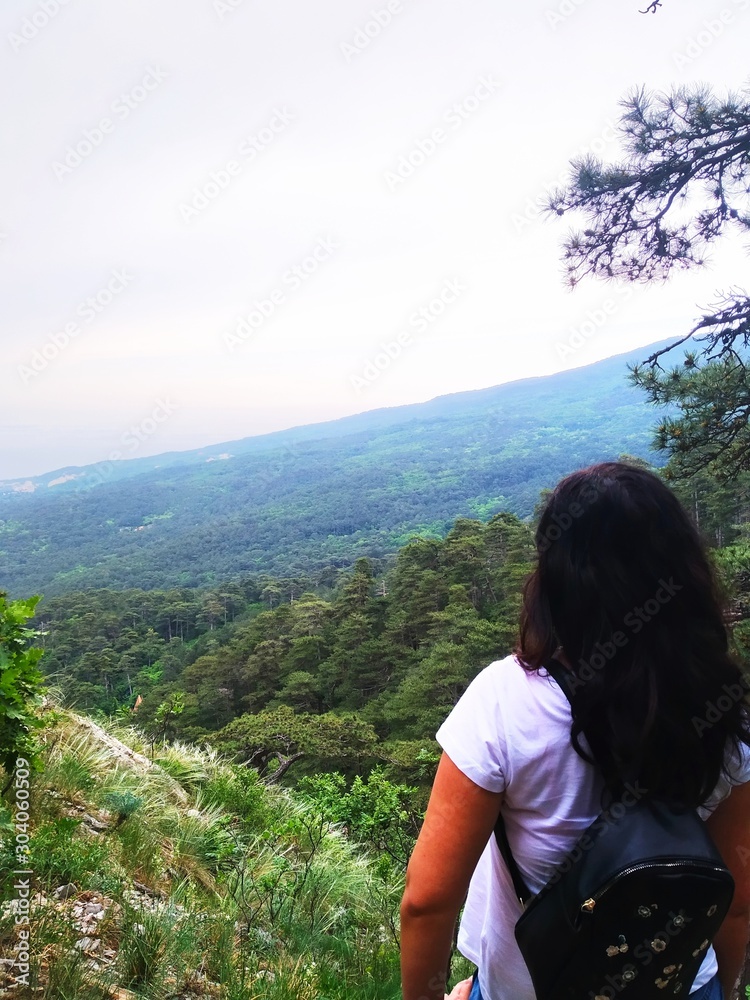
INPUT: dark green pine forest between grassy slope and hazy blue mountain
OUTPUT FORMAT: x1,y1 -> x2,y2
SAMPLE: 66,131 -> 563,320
38,513 -> 533,770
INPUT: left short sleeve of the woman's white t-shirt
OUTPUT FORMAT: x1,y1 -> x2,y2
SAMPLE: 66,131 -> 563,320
435,663 -> 507,792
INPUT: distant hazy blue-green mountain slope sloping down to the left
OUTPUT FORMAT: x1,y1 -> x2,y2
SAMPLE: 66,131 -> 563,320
0,341 -> 680,595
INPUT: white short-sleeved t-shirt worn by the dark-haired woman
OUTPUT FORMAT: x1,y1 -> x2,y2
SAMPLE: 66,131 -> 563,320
437,656 -> 750,1000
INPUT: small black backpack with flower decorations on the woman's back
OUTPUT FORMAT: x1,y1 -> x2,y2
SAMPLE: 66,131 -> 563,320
495,660 -> 734,1000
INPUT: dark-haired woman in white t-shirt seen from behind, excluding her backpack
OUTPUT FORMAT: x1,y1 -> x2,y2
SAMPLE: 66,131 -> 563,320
401,462 -> 750,1000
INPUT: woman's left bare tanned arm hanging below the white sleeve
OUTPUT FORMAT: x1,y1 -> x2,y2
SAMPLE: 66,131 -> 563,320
401,754 -> 502,1000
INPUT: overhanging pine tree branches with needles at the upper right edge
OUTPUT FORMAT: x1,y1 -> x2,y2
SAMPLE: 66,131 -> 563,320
548,86 -> 750,481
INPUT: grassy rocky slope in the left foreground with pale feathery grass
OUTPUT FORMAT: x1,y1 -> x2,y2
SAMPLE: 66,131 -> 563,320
0,711 -> 412,1000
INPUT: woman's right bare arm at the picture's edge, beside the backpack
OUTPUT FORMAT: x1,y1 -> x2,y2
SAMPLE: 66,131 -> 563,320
706,782 -> 750,998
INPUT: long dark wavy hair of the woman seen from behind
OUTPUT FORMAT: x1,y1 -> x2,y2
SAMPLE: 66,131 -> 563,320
516,462 -> 750,807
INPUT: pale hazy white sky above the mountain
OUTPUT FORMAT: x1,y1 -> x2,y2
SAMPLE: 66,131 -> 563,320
0,0 -> 750,479
